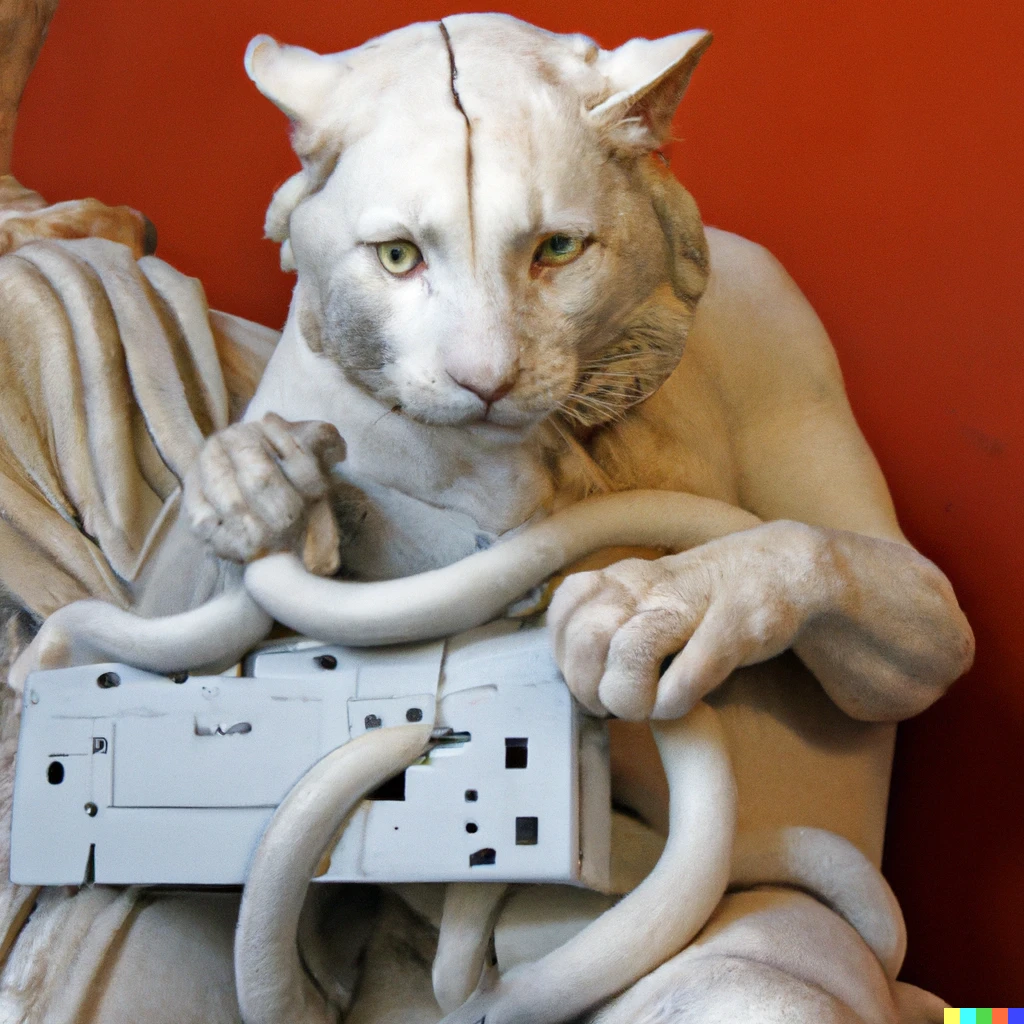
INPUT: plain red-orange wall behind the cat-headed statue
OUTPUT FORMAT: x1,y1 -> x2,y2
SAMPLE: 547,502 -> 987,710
14,0 -> 1024,1006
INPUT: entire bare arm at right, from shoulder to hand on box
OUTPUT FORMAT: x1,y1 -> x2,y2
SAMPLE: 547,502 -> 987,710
551,233 -> 974,720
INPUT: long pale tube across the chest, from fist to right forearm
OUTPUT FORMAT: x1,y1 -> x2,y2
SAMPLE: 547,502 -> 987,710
245,490 -> 761,646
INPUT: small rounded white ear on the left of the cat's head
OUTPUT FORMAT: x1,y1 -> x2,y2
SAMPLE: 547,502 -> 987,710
246,36 -> 338,125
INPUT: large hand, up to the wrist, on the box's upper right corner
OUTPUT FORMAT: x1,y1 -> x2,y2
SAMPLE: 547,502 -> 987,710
548,522 -> 835,721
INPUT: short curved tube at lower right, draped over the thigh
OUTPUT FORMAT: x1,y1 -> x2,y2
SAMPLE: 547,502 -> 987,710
729,826 -> 906,980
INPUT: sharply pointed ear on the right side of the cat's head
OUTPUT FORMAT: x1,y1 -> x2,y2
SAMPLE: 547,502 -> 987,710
590,29 -> 712,153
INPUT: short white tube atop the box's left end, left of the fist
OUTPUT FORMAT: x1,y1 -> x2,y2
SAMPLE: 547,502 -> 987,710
9,587 -> 273,690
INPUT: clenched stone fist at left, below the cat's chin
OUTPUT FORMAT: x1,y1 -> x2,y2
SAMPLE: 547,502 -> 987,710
184,413 -> 345,563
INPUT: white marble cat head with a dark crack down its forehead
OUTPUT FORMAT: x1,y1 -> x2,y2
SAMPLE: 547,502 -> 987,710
246,14 -> 711,432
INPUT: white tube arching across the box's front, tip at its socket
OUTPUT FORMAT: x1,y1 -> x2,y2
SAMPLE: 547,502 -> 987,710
234,723 -> 432,1024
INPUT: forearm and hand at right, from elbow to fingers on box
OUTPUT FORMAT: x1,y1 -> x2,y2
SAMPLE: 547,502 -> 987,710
550,521 -> 974,721
